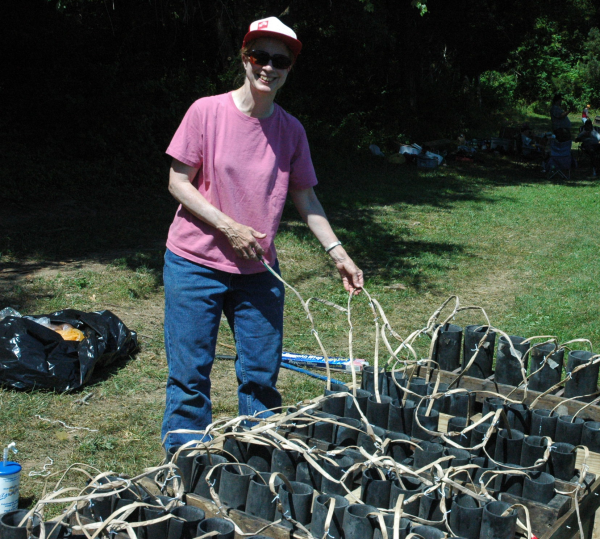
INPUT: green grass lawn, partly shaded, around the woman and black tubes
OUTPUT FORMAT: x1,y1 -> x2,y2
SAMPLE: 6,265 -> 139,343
0,141 -> 600,505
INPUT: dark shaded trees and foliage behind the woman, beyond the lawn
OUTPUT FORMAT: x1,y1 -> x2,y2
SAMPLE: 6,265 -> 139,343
0,0 -> 600,211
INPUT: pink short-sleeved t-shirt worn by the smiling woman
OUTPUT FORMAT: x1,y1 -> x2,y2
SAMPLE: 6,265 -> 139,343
167,93 -> 317,273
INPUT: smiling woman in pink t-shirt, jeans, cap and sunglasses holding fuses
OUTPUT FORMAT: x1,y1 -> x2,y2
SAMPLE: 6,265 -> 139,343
162,17 -> 363,448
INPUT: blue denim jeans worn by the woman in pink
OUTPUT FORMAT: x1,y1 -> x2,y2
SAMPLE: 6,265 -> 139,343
162,250 -> 284,449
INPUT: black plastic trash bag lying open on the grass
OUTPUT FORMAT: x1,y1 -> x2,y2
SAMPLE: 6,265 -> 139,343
0,309 -> 137,391
